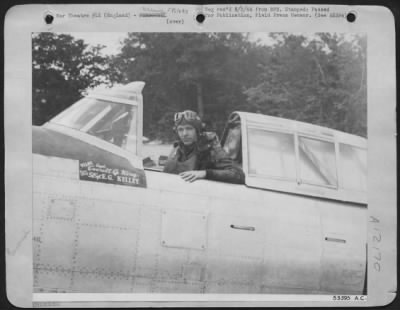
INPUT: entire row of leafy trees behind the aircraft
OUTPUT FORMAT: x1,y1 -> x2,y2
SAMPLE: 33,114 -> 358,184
33,33 -> 367,141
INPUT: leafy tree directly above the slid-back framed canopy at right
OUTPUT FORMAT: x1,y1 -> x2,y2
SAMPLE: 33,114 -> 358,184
240,33 -> 367,136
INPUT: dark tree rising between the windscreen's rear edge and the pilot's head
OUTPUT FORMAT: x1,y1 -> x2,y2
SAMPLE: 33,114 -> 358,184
114,33 -> 184,140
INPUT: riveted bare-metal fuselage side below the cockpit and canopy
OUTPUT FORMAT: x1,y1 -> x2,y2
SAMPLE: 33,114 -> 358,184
33,154 -> 367,294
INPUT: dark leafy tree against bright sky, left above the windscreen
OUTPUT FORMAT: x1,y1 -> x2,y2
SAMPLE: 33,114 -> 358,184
32,32 -> 119,125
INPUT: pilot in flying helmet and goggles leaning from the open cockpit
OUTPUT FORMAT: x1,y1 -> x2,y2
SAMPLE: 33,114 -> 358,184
164,110 -> 244,183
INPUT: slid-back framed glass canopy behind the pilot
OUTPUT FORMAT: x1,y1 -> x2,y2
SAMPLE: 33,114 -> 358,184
222,112 -> 367,204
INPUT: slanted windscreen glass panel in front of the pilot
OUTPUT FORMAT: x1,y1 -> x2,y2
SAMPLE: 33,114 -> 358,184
51,98 -> 137,153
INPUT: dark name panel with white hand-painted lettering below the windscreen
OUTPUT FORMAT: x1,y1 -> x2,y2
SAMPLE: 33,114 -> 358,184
79,161 -> 146,187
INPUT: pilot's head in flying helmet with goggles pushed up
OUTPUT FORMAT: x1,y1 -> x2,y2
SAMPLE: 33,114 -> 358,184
174,110 -> 202,146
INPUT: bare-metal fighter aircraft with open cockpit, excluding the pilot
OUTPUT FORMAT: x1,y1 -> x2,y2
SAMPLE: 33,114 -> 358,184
32,82 -> 367,294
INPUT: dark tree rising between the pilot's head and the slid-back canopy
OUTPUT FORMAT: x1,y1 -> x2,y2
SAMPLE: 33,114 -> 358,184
177,33 -> 257,131
